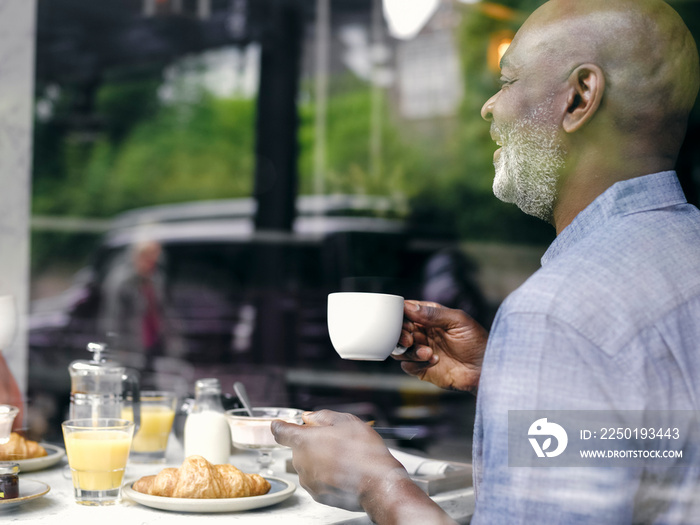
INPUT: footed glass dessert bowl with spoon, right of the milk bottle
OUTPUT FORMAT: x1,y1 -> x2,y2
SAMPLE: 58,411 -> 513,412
226,407 -> 303,476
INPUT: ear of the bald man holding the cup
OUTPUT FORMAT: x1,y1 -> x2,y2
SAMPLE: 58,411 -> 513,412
562,64 -> 605,133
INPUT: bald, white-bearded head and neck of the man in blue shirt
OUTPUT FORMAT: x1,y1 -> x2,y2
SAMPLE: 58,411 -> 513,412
481,0 -> 700,232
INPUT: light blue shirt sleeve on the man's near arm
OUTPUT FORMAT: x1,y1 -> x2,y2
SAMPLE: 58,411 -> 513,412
472,313 -> 639,524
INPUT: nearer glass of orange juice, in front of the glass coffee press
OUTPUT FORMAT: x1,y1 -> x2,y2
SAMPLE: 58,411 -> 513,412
61,418 -> 134,505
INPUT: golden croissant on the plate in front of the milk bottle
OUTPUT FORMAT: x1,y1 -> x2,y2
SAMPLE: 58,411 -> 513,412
133,456 -> 270,499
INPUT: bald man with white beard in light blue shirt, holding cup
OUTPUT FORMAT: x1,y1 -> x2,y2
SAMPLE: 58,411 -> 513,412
273,0 -> 700,524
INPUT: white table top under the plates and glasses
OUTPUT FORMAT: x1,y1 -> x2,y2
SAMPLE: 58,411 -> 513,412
0,437 -> 474,525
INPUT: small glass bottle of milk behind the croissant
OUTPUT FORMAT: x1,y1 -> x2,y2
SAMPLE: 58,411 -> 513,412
185,378 -> 231,465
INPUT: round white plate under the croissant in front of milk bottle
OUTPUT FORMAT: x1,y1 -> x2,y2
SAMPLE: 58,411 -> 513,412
122,476 -> 297,512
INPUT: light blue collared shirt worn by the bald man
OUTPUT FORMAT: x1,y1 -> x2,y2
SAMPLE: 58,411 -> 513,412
472,172 -> 700,525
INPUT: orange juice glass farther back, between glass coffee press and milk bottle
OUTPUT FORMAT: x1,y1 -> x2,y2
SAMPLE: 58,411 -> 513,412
122,390 -> 177,463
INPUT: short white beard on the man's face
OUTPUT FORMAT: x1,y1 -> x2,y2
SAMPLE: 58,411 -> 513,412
493,105 -> 566,222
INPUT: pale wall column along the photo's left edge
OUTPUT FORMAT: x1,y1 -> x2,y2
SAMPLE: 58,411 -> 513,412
0,0 -> 36,393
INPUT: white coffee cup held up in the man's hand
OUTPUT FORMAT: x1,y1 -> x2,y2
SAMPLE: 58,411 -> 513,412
328,292 -> 406,361
